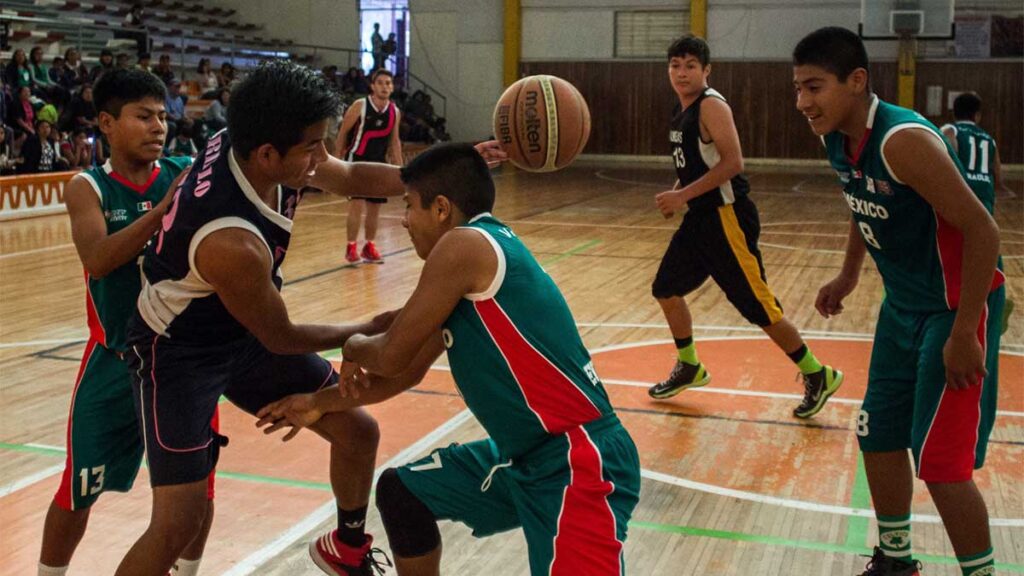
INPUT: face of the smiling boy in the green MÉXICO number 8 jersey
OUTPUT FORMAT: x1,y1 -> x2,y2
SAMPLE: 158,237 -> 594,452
793,65 -> 867,136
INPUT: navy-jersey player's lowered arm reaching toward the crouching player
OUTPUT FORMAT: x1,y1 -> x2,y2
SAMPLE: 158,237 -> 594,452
195,228 -> 374,354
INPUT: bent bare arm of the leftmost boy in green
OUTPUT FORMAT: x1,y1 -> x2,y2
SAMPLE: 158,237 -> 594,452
65,170 -> 188,278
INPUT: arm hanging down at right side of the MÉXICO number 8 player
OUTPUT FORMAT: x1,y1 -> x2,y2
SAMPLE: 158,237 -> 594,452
882,129 -> 999,388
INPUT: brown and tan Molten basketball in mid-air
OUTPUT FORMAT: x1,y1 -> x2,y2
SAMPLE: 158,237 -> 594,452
494,75 -> 590,172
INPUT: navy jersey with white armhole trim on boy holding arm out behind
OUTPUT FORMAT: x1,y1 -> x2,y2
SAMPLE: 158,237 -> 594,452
132,130 -> 301,344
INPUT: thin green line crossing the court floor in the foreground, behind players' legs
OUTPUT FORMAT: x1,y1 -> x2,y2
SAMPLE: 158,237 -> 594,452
0,442 -> 1024,574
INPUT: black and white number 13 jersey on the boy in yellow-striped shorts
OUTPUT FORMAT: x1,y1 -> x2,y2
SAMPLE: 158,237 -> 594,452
669,88 -> 750,210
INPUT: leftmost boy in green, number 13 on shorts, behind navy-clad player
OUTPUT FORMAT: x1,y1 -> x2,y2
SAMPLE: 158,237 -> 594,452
39,70 -> 216,576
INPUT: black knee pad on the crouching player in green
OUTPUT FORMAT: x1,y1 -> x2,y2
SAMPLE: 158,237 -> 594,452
377,468 -> 441,558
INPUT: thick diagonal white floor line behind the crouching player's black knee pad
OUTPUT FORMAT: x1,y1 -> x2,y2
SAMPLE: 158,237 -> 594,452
223,410 -> 473,576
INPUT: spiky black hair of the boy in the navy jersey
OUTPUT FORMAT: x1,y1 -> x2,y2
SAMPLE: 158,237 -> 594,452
227,60 -> 341,159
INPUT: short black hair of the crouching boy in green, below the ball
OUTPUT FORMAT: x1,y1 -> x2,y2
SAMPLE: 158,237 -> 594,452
401,143 -> 495,218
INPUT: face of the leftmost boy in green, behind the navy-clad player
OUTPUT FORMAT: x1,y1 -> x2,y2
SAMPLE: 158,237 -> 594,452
99,98 -> 167,162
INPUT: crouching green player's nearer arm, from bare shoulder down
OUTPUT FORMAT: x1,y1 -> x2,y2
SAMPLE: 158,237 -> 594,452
342,229 -> 498,377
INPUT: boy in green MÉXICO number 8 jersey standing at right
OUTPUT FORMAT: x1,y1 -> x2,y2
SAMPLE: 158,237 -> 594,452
793,28 -> 1005,576
